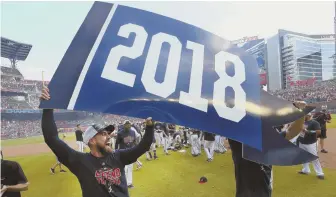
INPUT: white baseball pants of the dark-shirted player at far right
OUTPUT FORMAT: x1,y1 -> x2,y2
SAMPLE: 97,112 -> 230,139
299,142 -> 324,176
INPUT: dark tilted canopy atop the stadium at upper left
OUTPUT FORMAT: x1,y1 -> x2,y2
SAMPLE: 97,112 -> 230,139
1,37 -> 33,68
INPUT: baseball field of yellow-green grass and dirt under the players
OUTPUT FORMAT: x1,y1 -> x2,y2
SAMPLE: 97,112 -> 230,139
1,115 -> 336,197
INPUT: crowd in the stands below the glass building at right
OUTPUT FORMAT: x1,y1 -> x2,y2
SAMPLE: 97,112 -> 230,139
272,79 -> 336,103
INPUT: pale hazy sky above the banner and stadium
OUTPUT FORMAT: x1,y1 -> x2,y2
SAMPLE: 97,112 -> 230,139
1,1 -> 335,80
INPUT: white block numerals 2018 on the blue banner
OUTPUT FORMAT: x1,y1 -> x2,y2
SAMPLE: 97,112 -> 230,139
101,23 -> 246,122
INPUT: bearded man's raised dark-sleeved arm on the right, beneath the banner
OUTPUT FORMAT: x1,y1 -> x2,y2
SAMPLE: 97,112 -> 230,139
118,118 -> 154,165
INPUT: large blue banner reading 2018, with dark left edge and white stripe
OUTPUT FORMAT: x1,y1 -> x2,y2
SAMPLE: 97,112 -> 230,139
40,2 -> 315,165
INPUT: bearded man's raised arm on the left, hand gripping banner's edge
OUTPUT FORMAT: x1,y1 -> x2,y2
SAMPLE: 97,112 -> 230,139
41,87 -> 77,168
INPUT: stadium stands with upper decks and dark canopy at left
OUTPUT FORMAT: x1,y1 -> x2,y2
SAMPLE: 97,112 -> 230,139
1,37 -> 138,139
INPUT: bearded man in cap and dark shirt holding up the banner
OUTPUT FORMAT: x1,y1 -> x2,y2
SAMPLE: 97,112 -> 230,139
41,87 -> 154,197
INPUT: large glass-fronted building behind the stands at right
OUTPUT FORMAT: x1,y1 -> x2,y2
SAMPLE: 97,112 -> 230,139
265,29 -> 336,91
